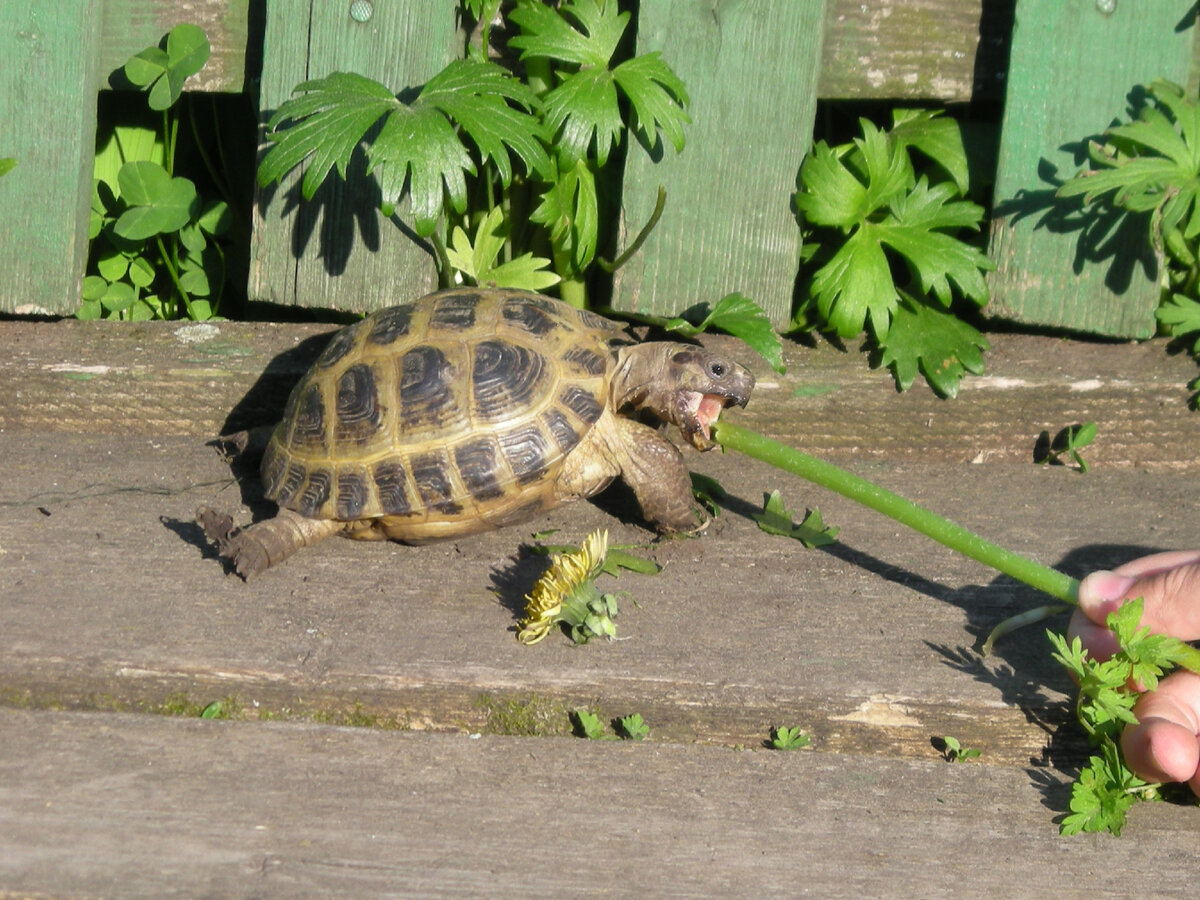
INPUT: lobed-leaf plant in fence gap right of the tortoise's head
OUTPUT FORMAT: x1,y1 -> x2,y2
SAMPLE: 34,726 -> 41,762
793,109 -> 995,396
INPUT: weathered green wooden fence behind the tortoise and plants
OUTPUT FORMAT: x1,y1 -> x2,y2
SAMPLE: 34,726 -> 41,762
0,0 -> 1196,337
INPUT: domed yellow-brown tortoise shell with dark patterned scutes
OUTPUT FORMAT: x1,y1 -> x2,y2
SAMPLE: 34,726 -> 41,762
263,288 -> 623,540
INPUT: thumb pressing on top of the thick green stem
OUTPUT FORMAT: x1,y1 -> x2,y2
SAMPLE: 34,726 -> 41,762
1079,553 -> 1200,641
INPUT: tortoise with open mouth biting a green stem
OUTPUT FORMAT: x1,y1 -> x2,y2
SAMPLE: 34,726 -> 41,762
198,288 -> 754,577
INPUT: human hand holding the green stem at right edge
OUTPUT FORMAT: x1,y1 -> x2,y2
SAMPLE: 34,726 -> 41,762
1067,551 -> 1200,796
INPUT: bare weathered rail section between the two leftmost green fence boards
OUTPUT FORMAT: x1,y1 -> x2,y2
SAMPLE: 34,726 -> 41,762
98,0 -> 250,94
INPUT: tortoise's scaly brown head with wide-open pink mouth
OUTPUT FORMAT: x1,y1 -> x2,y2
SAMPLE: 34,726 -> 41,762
612,342 -> 754,450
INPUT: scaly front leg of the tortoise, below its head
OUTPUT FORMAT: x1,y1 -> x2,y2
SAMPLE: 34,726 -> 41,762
613,418 -> 709,533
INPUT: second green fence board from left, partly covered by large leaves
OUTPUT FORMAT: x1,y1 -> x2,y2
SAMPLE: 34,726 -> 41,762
250,0 -> 461,311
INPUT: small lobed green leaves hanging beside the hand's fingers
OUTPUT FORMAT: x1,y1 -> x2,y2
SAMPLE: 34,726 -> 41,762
1046,598 -> 1200,835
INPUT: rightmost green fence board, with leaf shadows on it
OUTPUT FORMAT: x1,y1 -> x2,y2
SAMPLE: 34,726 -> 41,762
988,0 -> 1194,338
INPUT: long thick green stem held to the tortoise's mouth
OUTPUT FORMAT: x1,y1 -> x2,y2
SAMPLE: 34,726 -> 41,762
713,421 -> 1079,604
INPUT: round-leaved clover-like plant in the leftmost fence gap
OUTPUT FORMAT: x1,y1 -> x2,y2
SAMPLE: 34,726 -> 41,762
78,25 -> 232,320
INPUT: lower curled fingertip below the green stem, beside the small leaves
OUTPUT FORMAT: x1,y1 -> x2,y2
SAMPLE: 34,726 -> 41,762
1121,672 -> 1200,790
